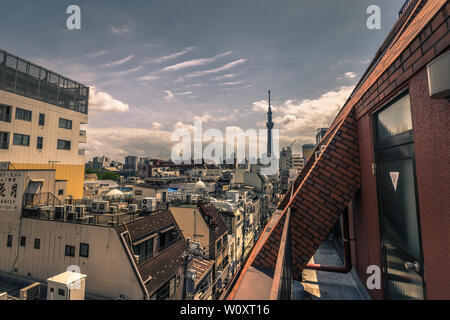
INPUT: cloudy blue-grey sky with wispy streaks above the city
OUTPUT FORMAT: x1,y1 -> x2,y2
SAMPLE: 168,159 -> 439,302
0,0 -> 404,161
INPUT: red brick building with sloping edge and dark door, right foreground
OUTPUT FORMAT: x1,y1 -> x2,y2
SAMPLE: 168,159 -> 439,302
223,0 -> 450,300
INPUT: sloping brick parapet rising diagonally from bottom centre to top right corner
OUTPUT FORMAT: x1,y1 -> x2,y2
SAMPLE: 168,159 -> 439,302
223,0 -> 450,299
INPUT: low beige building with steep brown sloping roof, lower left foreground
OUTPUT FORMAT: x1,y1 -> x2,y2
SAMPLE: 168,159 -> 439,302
0,170 -> 185,300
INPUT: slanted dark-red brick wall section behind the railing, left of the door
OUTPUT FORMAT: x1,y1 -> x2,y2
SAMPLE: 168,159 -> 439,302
253,112 -> 360,279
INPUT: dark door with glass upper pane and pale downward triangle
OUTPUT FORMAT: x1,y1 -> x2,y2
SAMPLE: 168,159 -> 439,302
375,95 -> 424,300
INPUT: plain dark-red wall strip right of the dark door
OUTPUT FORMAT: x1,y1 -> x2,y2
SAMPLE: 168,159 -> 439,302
409,69 -> 450,299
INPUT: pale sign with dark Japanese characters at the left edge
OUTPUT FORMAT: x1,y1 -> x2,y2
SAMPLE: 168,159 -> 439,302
0,171 -> 24,211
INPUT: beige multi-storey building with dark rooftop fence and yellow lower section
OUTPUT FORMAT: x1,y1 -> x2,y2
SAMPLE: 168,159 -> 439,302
0,51 -> 89,199
